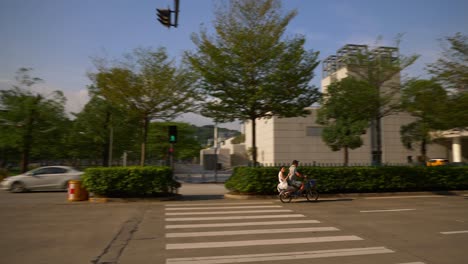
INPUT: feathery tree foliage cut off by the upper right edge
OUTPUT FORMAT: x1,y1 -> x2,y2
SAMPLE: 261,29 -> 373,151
427,33 -> 468,92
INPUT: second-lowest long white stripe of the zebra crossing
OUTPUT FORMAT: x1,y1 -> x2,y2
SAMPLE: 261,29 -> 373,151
166,236 -> 363,250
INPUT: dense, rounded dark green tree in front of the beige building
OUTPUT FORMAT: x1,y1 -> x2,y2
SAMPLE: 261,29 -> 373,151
317,77 -> 379,165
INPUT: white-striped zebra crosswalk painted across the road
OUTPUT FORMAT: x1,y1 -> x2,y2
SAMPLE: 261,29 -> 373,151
165,202 -> 424,264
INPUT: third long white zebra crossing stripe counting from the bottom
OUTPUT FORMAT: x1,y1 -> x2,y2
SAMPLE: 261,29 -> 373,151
166,227 -> 339,238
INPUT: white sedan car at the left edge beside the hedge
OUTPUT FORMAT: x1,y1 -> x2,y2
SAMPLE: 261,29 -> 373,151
1,166 -> 83,192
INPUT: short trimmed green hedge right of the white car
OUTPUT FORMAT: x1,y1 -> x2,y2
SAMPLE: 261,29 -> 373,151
82,166 -> 180,197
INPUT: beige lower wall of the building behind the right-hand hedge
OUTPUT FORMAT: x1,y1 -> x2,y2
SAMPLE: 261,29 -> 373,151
246,108 -> 448,165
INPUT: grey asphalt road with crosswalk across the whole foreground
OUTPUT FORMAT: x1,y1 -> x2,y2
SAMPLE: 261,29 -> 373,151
0,186 -> 468,264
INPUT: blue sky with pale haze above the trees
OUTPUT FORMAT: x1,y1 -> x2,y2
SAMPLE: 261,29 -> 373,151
0,0 -> 468,129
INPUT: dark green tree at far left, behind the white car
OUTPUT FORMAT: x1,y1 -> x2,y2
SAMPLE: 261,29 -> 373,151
0,68 -> 67,172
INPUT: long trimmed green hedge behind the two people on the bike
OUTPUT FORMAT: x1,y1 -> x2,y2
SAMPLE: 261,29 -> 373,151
225,166 -> 468,194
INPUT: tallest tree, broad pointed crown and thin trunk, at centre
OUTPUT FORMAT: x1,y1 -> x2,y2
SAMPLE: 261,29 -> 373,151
186,0 -> 319,164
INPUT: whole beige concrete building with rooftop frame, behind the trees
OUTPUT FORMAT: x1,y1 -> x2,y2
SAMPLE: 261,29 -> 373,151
244,45 -> 462,165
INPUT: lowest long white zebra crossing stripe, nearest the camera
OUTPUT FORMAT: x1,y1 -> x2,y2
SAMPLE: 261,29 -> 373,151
166,247 -> 395,264
